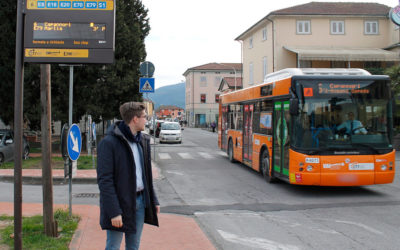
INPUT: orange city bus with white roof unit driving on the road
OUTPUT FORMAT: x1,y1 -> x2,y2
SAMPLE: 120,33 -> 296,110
218,68 -> 395,186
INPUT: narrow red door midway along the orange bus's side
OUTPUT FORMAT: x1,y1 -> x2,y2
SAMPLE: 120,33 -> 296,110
243,104 -> 254,166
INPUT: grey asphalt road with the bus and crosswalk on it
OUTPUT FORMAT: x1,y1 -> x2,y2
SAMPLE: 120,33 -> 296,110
0,128 -> 400,250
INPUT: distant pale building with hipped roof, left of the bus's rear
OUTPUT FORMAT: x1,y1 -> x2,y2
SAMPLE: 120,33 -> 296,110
183,63 -> 242,127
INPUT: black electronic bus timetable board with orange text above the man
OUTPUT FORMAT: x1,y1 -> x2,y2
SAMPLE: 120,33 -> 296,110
24,0 -> 115,63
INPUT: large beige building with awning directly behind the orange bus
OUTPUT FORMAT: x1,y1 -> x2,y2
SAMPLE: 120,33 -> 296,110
236,2 -> 400,87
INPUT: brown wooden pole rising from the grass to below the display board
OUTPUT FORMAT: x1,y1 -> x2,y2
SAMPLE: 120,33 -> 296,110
40,64 -> 57,237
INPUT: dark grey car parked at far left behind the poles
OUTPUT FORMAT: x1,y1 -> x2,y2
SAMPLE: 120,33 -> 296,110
0,129 -> 29,165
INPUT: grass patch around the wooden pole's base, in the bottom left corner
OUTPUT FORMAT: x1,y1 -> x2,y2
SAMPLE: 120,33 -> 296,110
0,209 -> 80,250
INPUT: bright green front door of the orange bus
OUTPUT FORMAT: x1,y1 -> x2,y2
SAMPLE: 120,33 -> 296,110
273,101 -> 290,178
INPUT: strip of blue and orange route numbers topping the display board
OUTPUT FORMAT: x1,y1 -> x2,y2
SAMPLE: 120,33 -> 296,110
26,0 -> 114,10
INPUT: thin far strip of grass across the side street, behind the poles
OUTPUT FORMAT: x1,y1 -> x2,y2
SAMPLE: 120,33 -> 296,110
0,155 -> 97,169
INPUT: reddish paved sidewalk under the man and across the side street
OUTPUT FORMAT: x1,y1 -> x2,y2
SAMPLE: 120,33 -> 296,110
0,165 -> 215,250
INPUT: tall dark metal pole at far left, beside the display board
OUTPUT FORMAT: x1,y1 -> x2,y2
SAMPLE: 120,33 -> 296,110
14,0 -> 24,250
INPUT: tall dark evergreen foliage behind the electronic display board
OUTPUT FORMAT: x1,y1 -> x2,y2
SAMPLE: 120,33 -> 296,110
0,0 -> 150,130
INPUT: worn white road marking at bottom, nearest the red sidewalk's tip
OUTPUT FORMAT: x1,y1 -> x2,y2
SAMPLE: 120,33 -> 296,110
217,229 -> 300,250
